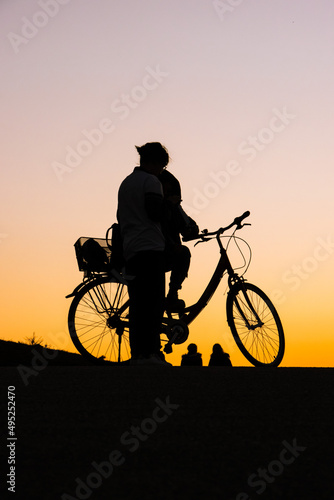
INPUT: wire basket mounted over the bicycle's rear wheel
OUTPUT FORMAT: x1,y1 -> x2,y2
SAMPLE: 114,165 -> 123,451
74,237 -> 111,273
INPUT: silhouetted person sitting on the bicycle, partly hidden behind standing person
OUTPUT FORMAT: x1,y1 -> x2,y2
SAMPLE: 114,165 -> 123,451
158,170 -> 199,313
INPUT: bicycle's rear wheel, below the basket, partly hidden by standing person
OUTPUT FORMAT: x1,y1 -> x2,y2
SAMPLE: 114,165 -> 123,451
68,277 -> 131,363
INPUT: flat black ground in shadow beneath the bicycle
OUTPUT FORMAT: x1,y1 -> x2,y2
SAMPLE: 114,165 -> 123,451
0,344 -> 334,500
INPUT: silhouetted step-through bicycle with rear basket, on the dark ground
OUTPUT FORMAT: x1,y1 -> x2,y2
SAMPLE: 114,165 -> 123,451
67,212 -> 285,367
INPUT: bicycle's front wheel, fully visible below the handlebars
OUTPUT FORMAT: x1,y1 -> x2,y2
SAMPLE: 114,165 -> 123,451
226,282 -> 285,366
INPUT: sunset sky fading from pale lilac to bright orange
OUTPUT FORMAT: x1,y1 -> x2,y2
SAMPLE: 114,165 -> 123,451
0,0 -> 334,366
